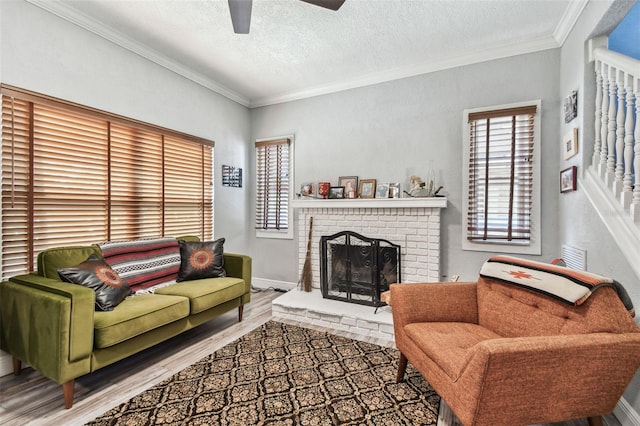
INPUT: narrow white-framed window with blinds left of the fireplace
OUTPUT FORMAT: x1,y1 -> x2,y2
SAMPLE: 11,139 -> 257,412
255,138 -> 293,238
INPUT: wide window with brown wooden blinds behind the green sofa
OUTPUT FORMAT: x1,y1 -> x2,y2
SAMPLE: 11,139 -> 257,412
2,86 -> 213,277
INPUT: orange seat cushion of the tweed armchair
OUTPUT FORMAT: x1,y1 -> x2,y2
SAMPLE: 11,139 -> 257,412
404,322 -> 501,380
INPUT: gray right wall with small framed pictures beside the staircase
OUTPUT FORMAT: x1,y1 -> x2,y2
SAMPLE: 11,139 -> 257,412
558,1 -> 640,413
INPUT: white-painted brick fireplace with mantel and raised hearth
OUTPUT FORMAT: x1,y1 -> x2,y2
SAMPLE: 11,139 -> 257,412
273,198 -> 447,339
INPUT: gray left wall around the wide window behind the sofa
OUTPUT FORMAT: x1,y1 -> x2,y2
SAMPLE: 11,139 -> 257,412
0,1 -> 250,252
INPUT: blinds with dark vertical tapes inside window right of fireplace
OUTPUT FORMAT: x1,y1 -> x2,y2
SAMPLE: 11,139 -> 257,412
467,105 -> 536,244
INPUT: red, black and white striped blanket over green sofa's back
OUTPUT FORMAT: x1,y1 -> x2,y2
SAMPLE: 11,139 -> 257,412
98,238 -> 180,291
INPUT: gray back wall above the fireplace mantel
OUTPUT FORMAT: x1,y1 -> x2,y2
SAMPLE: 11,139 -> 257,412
251,49 -> 560,282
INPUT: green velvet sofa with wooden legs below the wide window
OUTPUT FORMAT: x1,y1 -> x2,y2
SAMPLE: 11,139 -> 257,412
0,237 -> 251,408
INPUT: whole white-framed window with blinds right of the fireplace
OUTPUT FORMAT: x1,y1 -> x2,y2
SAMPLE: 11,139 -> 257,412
463,101 -> 540,254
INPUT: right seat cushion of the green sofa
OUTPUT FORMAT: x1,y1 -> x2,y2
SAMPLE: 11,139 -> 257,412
156,277 -> 244,314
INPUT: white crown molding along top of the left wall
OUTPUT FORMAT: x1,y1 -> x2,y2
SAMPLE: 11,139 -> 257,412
26,0 -> 250,107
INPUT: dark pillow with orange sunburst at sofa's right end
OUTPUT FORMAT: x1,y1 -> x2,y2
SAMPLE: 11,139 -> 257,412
176,238 -> 227,282
